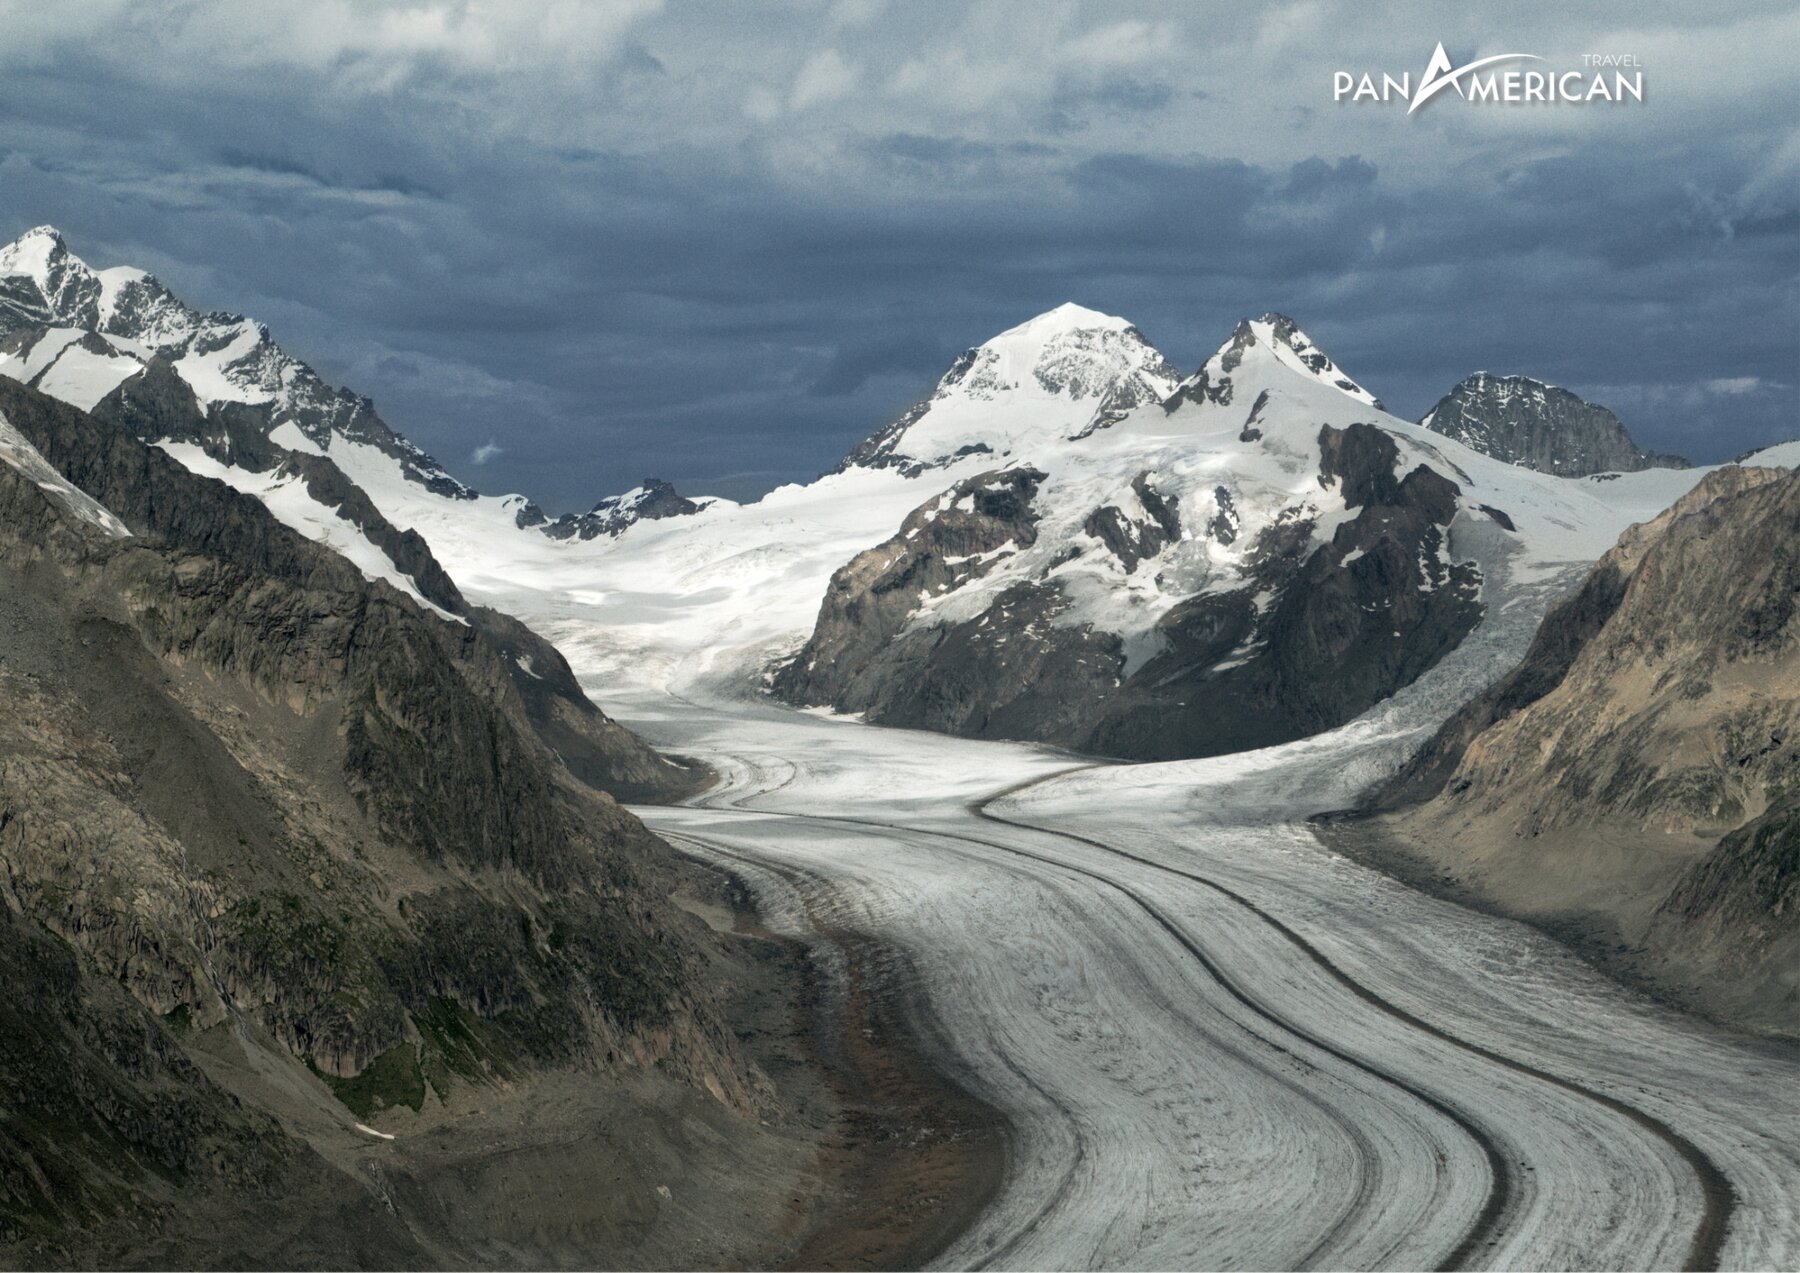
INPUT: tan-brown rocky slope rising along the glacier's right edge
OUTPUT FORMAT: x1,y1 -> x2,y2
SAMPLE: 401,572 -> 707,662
1377,468 -> 1800,1034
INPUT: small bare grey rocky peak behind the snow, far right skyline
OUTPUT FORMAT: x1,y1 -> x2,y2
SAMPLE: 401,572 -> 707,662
1418,371 -> 1688,477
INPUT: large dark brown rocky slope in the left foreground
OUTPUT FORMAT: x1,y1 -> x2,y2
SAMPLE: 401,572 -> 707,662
0,372 -> 761,1262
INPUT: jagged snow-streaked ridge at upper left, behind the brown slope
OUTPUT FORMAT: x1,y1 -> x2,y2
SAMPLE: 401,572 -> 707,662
0,227 -> 700,799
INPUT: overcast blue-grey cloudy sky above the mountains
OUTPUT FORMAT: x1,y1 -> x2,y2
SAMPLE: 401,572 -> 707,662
0,0 -> 1800,511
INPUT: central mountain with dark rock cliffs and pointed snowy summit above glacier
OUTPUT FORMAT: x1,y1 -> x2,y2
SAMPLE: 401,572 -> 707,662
772,315 -> 1679,760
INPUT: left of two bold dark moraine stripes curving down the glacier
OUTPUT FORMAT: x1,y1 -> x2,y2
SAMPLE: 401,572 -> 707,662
675,803 -> 1516,1269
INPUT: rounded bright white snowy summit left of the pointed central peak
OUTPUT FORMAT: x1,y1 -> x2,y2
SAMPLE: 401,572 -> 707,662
844,302 -> 1181,472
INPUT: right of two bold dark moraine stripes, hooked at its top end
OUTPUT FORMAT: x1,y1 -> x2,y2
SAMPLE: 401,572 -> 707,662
968,765 -> 1737,1269
